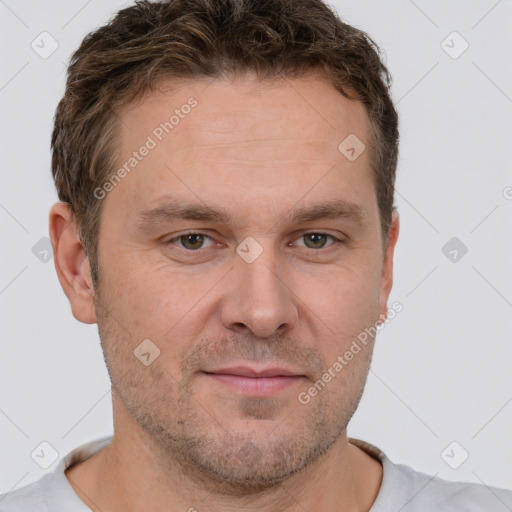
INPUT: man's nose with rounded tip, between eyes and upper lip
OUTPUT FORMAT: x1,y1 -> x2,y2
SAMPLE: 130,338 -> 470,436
220,249 -> 298,338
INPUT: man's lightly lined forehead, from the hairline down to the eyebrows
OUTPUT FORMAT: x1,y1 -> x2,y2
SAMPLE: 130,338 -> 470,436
109,75 -> 374,226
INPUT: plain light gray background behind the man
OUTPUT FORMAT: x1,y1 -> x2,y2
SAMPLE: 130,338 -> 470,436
0,0 -> 512,492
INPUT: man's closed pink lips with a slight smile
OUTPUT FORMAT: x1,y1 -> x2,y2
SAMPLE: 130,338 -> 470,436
203,366 -> 306,397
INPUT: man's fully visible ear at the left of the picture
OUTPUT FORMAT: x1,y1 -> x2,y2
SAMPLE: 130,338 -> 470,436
50,202 -> 96,324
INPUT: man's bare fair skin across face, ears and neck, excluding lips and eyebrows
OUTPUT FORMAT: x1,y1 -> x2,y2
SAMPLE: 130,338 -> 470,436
50,73 -> 399,512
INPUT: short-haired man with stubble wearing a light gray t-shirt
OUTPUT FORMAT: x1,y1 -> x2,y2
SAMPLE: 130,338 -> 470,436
0,0 -> 512,512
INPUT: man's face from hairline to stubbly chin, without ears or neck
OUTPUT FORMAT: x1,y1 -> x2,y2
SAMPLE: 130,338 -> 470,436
91,72 -> 394,486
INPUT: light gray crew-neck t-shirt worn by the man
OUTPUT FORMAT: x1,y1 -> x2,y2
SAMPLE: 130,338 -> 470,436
0,437 -> 512,512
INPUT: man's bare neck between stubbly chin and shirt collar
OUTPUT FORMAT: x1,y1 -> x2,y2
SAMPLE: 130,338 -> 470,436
66,396 -> 382,512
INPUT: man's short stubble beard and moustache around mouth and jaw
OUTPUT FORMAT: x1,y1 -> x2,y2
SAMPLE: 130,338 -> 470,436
93,286 -> 371,496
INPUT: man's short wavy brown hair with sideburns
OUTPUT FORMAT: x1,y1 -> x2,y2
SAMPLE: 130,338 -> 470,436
51,0 -> 399,282
